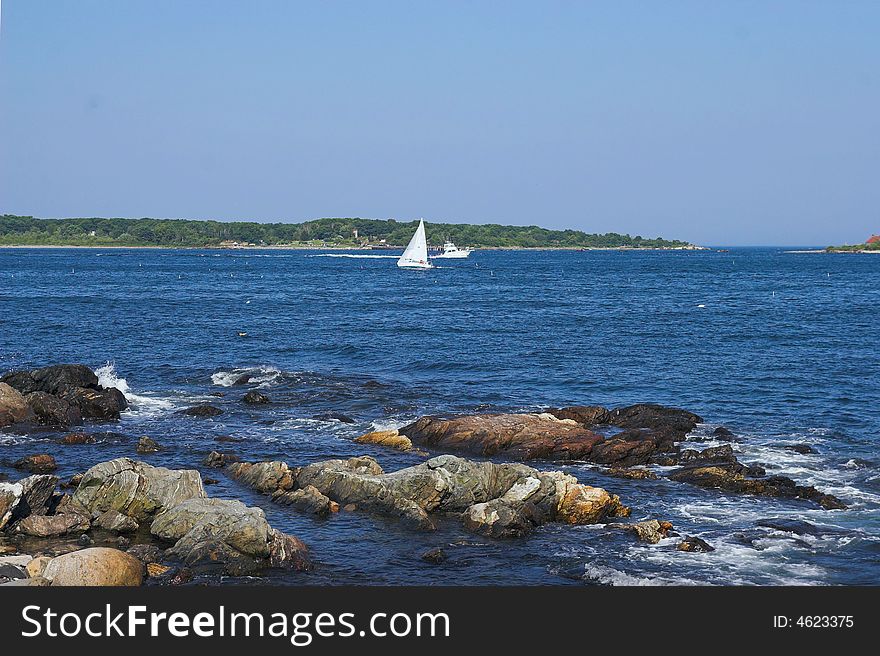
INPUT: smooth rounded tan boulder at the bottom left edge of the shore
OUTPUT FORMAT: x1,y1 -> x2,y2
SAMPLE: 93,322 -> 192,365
43,547 -> 144,586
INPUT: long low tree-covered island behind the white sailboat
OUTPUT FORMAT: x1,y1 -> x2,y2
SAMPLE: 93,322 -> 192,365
0,214 -> 700,250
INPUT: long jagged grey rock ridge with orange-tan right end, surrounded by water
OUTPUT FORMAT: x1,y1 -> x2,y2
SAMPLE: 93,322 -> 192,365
235,456 -> 629,537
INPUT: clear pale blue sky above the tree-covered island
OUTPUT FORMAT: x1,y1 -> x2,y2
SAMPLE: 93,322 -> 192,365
0,0 -> 880,245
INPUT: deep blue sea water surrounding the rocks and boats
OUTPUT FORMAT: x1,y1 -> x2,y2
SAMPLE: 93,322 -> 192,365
0,248 -> 880,585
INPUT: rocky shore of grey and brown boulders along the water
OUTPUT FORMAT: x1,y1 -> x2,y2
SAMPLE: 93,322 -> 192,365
0,365 -> 846,586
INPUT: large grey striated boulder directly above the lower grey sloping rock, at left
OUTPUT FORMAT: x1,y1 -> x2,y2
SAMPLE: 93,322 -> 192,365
73,458 -> 206,521
